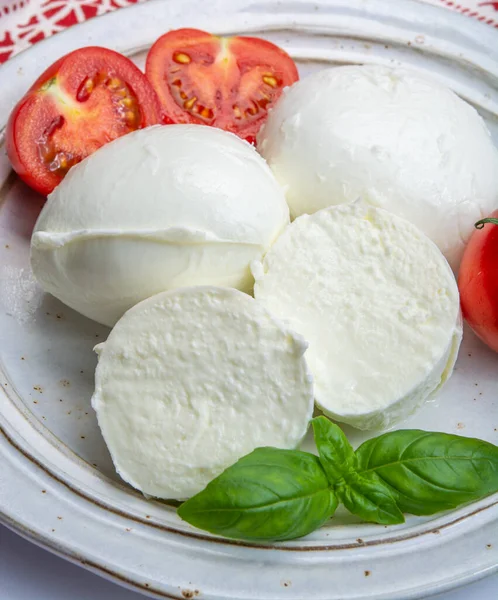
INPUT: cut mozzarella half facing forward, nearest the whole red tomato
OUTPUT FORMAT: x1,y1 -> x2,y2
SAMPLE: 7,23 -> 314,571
253,204 -> 462,429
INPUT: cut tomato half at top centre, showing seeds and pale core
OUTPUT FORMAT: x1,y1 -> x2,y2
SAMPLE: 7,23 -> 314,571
145,29 -> 299,141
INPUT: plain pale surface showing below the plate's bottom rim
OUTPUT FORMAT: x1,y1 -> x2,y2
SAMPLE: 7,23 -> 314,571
0,526 -> 498,600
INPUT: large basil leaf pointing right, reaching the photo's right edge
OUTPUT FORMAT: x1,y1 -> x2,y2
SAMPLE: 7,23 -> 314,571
356,430 -> 498,515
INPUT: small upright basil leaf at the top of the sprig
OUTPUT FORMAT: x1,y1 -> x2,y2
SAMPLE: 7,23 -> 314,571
311,417 -> 357,484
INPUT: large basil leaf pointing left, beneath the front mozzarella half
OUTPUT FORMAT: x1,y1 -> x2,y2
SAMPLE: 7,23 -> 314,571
178,448 -> 337,541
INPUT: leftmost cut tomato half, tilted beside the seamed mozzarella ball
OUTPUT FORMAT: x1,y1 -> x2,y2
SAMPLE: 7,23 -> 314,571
7,47 -> 161,194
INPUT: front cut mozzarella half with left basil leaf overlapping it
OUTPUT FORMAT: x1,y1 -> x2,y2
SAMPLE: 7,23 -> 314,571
92,287 -> 313,500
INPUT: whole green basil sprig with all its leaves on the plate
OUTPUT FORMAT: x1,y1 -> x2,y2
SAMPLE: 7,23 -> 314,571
178,417 -> 498,541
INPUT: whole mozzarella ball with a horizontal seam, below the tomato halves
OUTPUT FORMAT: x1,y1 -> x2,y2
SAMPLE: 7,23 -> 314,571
31,125 -> 289,326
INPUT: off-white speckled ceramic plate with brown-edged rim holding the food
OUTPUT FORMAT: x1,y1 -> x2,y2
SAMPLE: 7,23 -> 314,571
0,0 -> 498,600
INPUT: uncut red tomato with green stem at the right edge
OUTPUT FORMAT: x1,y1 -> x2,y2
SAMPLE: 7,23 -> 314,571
458,210 -> 498,352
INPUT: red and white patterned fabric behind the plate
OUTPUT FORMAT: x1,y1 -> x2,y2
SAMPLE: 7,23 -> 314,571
0,0 -> 498,63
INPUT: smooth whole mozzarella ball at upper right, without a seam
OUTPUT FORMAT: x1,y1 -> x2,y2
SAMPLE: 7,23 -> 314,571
258,65 -> 498,270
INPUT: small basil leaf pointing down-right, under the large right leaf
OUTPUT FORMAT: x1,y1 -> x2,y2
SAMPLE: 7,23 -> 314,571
334,474 -> 405,525
